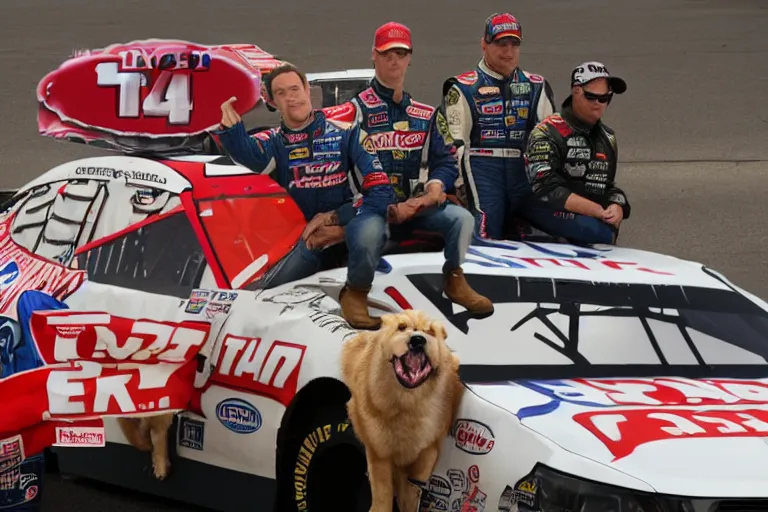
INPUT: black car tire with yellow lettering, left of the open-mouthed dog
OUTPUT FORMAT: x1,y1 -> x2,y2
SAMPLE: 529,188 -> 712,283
277,403 -> 396,512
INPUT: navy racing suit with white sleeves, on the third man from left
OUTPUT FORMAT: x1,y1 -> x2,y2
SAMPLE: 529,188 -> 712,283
443,60 -> 554,239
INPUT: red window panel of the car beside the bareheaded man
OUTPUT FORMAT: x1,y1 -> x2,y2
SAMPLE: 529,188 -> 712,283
198,196 -> 304,288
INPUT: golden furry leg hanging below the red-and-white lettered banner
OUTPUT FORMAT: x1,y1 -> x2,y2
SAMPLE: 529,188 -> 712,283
117,412 -> 173,480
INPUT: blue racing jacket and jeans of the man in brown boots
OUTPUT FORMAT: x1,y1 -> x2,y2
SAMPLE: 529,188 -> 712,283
347,78 -> 473,288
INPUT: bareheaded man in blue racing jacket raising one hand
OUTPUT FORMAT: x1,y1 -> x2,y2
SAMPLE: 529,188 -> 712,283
212,63 -> 395,288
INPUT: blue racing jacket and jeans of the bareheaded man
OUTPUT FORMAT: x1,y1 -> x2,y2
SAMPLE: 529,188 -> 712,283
212,110 -> 395,287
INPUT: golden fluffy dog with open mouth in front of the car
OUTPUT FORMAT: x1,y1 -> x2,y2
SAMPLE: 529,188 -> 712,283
341,310 -> 464,512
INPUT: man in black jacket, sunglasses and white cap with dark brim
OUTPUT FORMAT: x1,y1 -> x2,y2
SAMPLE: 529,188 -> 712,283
526,62 -> 630,244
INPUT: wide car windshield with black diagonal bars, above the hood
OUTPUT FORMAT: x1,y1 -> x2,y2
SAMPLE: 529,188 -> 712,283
409,275 -> 768,382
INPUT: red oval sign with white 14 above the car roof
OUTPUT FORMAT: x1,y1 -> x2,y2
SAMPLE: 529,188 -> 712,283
37,39 -> 280,148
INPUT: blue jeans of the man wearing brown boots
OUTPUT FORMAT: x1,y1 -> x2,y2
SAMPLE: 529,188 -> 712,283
346,203 -> 474,288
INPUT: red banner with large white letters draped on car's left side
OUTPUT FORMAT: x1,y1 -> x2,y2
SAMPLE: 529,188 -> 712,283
0,310 -> 210,453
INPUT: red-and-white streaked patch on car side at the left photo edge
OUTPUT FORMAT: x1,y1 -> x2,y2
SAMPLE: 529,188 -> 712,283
0,215 -> 86,319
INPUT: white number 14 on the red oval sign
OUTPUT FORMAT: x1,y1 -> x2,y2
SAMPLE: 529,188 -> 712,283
96,62 -> 192,124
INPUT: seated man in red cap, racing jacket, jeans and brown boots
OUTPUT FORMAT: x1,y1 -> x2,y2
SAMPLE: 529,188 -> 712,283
341,22 -> 493,328
